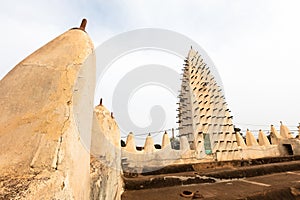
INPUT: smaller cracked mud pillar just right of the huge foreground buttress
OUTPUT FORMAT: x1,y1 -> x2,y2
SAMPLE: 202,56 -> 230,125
90,105 -> 123,200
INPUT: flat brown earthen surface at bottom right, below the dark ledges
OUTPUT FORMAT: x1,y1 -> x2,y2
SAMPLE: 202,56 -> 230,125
122,168 -> 300,200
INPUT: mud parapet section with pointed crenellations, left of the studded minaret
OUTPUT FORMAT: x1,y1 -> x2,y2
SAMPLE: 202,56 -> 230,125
122,133 -> 211,173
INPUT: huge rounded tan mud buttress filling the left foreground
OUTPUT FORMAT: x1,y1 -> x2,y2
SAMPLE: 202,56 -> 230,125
0,29 -> 95,199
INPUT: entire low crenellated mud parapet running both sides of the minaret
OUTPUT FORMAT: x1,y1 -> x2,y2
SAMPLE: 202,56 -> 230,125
122,124 -> 300,173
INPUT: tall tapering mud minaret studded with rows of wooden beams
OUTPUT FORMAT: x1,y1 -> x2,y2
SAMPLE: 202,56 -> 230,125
178,49 -> 237,155
